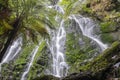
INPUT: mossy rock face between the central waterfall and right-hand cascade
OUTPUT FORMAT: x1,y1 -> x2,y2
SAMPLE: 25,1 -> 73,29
65,20 -> 103,74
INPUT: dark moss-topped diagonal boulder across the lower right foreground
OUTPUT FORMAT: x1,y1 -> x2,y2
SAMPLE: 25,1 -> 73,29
62,41 -> 120,80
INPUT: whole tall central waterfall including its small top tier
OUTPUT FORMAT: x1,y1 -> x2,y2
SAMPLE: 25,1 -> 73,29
48,0 -> 68,77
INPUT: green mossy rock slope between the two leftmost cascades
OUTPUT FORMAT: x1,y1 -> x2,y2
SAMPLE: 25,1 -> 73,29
2,43 -> 35,80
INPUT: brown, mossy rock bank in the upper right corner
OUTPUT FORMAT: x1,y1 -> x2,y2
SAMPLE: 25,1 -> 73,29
79,0 -> 120,26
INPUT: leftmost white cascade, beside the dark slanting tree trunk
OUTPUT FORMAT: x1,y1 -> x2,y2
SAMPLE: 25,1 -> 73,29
1,37 -> 22,64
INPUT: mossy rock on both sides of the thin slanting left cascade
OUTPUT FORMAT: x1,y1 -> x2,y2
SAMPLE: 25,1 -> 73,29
0,42 -> 47,80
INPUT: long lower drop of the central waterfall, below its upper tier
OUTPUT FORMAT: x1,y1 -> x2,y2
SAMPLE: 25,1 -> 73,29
48,20 -> 68,77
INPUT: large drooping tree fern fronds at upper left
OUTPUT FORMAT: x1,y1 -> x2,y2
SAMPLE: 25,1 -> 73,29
9,0 -> 58,42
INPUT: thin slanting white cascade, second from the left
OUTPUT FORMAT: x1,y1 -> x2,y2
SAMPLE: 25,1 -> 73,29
21,42 -> 41,80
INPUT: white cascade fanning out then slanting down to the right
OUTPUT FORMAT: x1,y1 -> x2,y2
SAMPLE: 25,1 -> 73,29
70,15 -> 107,51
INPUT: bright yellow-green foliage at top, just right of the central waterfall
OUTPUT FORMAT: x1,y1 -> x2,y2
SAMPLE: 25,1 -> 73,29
60,0 -> 93,19
